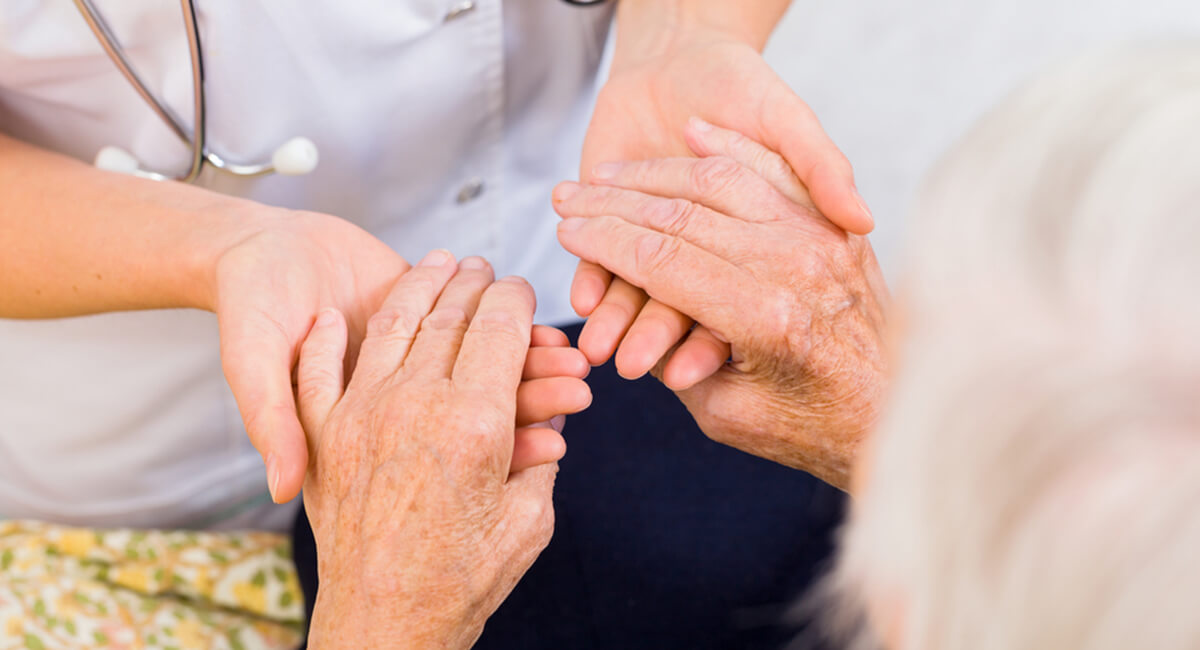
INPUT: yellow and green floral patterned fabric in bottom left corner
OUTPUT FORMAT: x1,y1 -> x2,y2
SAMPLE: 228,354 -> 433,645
0,520 -> 304,650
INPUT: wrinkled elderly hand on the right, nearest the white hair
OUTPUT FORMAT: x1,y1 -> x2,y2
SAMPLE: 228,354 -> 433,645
556,120 -> 887,489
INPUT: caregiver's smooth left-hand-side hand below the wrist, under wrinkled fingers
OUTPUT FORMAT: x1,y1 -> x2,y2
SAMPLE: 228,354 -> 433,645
214,210 -> 587,502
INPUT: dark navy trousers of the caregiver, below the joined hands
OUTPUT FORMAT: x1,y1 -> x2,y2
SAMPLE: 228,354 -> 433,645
294,326 -> 845,650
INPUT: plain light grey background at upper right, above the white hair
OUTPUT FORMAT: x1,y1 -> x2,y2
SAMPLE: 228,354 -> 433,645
763,0 -> 1200,282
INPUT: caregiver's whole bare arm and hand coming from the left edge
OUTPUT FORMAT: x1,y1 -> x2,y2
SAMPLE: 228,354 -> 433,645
0,136 -> 590,501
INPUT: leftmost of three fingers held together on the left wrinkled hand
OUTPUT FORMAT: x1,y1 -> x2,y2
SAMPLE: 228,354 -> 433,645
350,251 -> 457,390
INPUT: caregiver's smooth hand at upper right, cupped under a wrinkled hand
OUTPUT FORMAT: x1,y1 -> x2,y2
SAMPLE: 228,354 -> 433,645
571,29 -> 872,388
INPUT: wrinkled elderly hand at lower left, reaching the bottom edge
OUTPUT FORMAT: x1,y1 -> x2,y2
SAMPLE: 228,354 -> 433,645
298,253 -> 586,648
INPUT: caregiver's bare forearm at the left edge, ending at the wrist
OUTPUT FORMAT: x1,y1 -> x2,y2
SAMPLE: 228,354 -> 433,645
0,134 -> 271,318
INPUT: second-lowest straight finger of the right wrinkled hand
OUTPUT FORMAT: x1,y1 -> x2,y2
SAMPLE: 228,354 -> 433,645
554,182 -> 739,259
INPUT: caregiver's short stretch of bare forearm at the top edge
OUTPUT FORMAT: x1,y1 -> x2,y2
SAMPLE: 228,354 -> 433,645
613,0 -> 791,66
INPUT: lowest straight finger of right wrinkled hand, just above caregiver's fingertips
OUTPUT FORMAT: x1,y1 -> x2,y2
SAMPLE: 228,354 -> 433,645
558,217 -> 753,341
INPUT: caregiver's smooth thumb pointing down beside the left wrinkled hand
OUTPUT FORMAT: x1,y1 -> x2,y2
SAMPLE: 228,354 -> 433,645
220,319 -> 308,504
